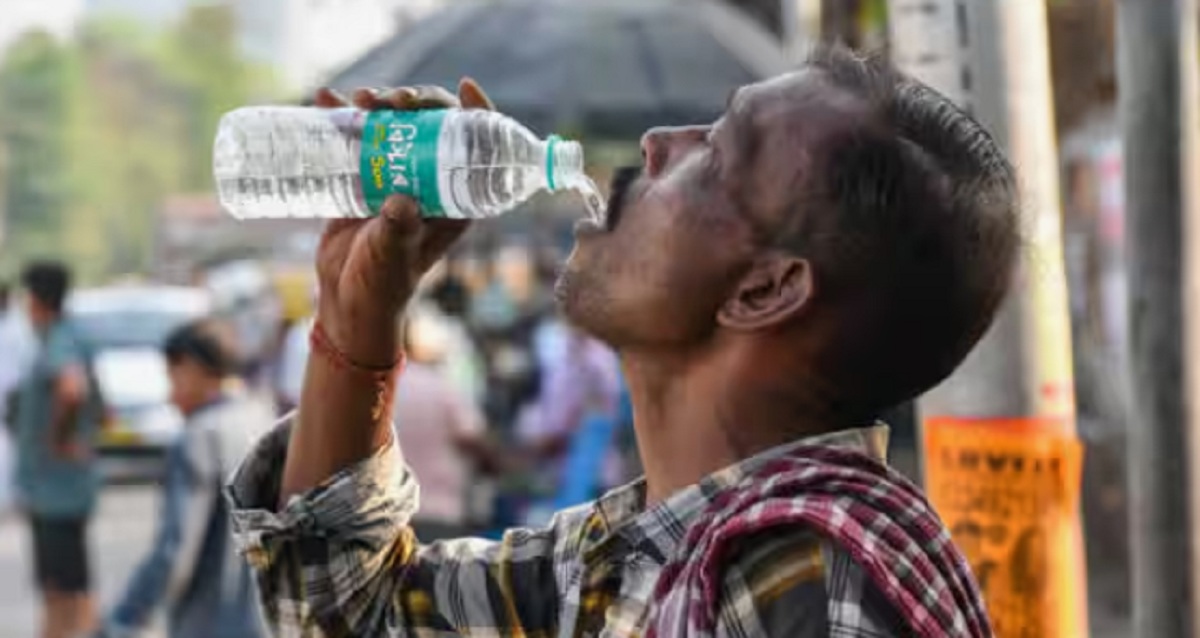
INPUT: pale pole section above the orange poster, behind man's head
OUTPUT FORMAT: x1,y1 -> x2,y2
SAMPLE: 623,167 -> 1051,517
889,0 -> 1074,424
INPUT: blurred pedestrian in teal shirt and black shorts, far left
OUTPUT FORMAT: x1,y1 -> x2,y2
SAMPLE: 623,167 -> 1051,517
17,261 -> 102,638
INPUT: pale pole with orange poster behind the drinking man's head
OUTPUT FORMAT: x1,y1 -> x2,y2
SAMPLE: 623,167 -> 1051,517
888,0 -> 1089,638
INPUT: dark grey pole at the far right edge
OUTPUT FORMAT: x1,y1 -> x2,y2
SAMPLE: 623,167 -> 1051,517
1117,0 -> 1200,638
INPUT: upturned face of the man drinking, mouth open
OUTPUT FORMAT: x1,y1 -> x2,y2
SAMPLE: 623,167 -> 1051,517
556,71 -> 859,349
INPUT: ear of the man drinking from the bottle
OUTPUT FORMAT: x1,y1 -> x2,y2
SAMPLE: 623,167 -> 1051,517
716,253 -> 814,331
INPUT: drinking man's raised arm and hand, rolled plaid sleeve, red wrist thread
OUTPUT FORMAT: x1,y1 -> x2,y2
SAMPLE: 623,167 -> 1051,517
229,80 -> 568,638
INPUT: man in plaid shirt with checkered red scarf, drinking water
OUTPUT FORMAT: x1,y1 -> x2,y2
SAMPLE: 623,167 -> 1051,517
230,50 -> 1018,638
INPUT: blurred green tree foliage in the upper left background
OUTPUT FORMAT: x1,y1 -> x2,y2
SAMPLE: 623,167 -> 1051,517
0,5 -> 272,281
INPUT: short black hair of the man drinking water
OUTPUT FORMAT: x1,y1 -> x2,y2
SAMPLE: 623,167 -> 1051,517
787,47 -> 1020,411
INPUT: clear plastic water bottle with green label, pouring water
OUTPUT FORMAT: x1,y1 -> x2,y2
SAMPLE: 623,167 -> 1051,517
212,107 -> 602,219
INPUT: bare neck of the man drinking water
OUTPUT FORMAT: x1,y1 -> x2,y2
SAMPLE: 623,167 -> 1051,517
622,345 -> 832,505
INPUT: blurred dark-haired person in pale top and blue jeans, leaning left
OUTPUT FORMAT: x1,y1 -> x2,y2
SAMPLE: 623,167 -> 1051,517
97,320 -> 272,638
